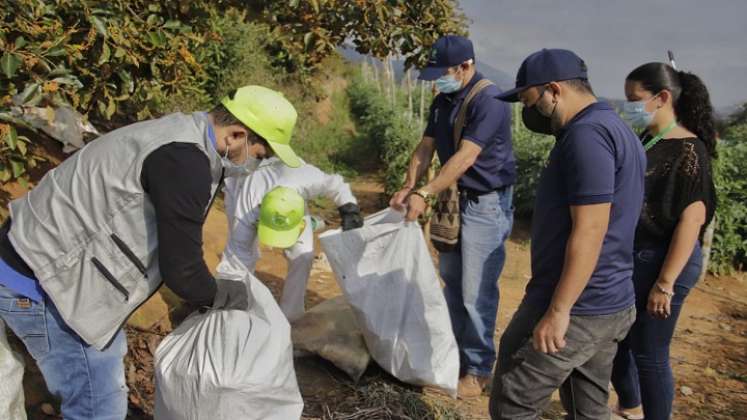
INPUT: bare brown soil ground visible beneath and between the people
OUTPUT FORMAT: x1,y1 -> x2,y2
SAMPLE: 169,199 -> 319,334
0,172 -> 747,419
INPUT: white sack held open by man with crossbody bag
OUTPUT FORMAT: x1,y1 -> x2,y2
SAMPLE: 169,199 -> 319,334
319,209 -> 459,396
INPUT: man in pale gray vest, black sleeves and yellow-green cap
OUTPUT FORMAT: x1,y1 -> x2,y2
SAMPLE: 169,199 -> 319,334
0,86 -> 301,420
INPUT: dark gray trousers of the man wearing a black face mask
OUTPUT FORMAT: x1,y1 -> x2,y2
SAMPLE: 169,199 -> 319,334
490,302 -> 635,420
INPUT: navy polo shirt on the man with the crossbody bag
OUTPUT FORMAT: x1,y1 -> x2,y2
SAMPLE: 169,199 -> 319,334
424,73 -> 516,192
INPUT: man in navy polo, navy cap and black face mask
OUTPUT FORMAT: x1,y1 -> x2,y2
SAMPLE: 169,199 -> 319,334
490,50 -> 646,420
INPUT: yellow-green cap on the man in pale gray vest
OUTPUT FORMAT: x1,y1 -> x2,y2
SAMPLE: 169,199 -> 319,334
221,85 -> 301,168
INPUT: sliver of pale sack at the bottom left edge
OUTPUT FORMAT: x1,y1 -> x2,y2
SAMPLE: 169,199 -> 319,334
0,320 -> 26,420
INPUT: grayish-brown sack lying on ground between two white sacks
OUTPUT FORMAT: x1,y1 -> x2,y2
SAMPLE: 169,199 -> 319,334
291,296 -> 371,382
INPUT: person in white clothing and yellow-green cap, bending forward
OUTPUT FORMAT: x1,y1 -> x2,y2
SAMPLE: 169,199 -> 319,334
217,157 -> 363,321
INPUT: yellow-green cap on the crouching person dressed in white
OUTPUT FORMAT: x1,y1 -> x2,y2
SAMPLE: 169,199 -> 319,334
257,187 -> 305,248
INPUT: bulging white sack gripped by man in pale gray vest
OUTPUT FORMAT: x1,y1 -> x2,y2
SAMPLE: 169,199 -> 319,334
155,272 -> 303,420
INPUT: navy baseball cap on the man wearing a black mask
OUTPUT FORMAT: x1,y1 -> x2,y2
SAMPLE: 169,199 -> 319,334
498,49 -> 588,102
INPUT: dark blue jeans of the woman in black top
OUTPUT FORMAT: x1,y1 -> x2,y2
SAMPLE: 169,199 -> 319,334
612,244 -> 702,420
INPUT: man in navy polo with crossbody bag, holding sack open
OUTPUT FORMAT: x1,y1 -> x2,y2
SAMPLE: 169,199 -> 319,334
390,36 -> 516,398
